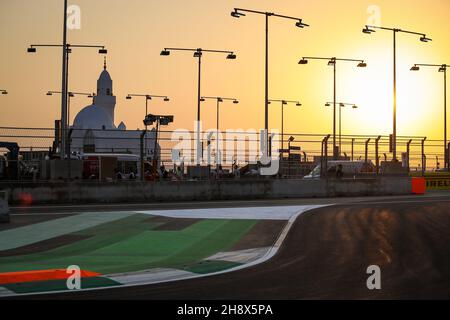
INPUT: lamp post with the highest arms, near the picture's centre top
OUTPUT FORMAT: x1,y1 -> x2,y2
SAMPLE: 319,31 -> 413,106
231,8 -> 309,154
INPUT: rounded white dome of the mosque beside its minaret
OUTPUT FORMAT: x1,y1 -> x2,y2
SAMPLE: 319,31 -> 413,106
73,105 -> 115,129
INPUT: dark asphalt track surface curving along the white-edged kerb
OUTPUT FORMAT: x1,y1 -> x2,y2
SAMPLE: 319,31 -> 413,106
21,197 -> 450,299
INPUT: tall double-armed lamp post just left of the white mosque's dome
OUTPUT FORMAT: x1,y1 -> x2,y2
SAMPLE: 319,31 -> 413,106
27,43 -> 108,159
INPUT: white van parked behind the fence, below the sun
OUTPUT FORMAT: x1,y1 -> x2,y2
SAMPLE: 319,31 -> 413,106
303,160 -> 374,180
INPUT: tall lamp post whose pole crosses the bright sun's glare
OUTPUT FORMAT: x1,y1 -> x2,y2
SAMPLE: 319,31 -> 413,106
362,25 -> 432,161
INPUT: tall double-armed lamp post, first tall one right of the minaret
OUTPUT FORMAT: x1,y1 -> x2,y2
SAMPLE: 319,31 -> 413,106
161,48 -> 236,166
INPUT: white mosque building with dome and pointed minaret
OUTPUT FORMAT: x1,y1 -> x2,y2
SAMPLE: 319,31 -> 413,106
70,60 -> 159,158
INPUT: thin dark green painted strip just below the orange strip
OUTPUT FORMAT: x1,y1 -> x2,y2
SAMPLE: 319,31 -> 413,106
3,277 -> 120,293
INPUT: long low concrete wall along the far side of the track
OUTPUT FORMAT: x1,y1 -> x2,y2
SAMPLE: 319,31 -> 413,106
1,177 -> 412,204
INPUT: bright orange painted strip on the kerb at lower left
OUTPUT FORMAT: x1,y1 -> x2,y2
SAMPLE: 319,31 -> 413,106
0,269 -> 100,285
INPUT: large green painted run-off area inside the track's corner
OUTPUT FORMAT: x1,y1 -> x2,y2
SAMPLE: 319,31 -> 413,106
0,214 -> 256,274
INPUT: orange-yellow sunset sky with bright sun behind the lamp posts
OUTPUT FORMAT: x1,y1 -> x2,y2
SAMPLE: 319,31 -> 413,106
0,0 -> 450,139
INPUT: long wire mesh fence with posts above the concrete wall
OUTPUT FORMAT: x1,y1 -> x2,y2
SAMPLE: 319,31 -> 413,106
0,127 -> 445,180
